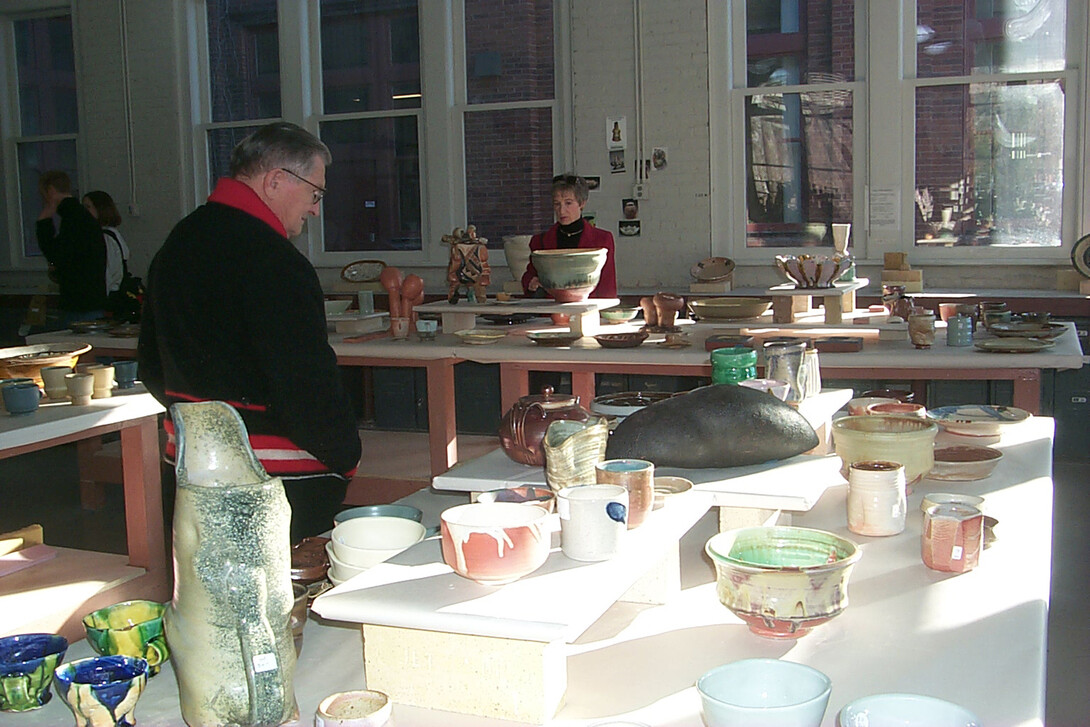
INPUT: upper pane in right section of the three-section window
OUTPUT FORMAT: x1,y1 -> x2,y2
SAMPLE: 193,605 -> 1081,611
465,0 -> 558,104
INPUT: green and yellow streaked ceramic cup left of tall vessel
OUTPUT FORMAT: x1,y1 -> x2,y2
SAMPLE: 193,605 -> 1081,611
83,601 -> 170,677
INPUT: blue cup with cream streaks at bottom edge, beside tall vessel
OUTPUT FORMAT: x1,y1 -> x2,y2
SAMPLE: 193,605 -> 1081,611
53,656 -> 147,727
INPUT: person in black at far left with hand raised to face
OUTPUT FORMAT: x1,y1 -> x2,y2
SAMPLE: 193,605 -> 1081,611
36,171 -> 106,327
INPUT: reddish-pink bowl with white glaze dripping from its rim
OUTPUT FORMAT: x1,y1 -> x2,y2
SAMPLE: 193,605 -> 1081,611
440,502 -> 552,585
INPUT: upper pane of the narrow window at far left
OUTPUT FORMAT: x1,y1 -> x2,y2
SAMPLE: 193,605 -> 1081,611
13,15 -> 78,135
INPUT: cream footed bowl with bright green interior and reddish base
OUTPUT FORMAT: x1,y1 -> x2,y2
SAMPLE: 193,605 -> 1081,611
704,526 -> 860,639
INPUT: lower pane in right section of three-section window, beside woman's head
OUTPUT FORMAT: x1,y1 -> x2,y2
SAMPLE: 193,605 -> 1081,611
465,109 -> 554,247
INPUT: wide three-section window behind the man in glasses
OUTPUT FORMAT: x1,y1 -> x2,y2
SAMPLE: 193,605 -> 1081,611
192,0 -> 559,265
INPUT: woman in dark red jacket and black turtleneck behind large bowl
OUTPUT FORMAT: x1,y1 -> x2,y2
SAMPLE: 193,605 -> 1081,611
522,174 -> 617,298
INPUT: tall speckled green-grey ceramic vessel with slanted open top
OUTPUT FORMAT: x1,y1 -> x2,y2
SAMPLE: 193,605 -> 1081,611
164,401 -> 299,727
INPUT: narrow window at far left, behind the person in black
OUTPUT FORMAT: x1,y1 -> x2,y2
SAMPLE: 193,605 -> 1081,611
12,15 -> 80,257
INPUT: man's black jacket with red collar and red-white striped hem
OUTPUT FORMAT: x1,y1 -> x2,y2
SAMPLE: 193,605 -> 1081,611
138,179 -> 361,478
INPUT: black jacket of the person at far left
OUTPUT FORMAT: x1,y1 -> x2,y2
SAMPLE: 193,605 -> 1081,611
37,197 -> 106,312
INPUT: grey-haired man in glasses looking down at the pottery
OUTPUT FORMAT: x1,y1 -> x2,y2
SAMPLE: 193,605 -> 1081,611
137,122 -> 361,543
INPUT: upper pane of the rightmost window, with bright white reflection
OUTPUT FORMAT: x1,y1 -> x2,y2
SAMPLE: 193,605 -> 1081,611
916,0 -> 1067,78
